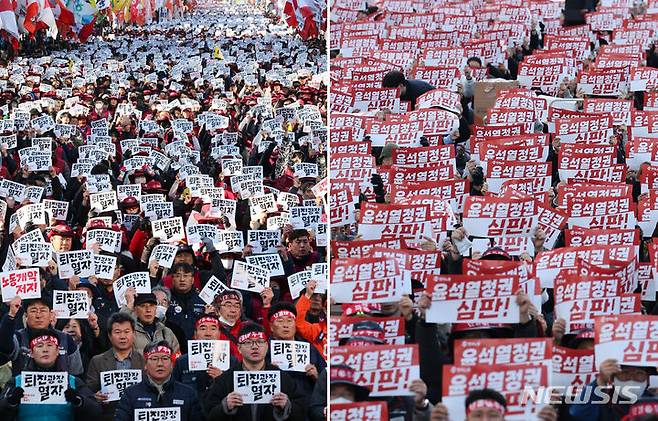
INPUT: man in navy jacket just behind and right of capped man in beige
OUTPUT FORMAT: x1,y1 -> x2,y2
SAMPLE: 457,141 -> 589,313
166,263 -> 206,353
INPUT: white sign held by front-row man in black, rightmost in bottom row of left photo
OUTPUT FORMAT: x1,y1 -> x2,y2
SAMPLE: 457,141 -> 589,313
233,370 -> 281,404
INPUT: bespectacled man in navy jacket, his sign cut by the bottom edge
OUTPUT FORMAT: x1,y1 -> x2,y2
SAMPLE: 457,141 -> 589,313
114,341 -> 201,421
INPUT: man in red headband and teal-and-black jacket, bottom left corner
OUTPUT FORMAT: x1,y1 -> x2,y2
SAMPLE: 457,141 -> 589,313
0,329 -> 101,421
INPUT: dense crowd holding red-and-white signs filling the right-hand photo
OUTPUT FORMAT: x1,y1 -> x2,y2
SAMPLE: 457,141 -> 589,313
329,0 -> 658,421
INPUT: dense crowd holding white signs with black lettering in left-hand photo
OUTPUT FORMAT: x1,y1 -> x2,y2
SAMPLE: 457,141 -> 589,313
0,2 -> 328,421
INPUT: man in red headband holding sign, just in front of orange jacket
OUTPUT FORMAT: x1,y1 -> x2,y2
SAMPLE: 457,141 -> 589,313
268,302 -> 327,398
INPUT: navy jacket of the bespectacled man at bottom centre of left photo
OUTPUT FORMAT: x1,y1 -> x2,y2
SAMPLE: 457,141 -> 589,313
113,376 -> 203,421
